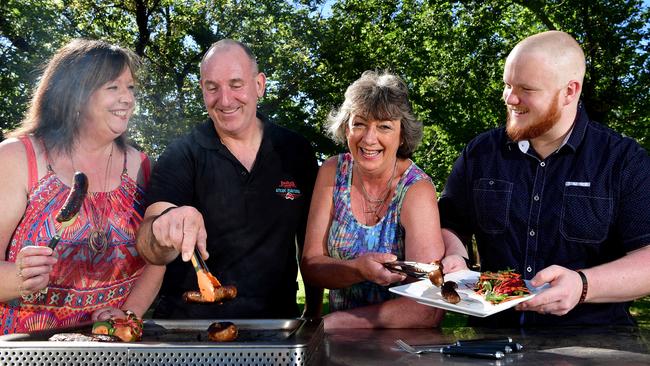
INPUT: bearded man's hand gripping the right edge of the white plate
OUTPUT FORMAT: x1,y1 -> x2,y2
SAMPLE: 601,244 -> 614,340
515,265 -> 582,315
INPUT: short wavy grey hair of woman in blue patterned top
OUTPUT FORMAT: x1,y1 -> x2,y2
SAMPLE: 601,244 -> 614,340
327,70 -> 423,159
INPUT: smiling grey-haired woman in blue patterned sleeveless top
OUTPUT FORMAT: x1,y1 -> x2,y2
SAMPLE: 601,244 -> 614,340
301,71 -> 444,329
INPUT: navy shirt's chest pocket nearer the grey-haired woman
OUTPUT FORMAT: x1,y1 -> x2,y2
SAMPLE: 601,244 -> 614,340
474,178 -> 513,234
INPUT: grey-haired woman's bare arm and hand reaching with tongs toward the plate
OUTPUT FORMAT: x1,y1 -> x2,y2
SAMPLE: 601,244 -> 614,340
300,157 -> 403,288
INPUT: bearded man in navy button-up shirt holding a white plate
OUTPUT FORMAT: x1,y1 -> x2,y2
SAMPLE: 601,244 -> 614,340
439,31 -> 650,327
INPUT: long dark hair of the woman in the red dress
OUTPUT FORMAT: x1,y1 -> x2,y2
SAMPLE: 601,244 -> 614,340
9,39 -> 140,153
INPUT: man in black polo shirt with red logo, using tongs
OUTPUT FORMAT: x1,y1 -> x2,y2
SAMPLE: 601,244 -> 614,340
137,39 -> 322,318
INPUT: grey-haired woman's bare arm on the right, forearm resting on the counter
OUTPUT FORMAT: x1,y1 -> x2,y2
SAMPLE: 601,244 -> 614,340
318,176 -> 444,329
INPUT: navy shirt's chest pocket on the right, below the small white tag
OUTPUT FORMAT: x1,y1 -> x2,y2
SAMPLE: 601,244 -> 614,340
560,186 -> 613,244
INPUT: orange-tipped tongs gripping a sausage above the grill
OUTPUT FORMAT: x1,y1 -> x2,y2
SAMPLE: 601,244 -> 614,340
183,248 -> 237,303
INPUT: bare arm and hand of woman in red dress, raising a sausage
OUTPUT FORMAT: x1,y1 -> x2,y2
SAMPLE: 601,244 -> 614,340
0,139 -> 56,301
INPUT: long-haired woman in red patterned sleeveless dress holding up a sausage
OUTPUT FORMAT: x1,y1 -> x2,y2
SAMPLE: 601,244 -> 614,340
0,40 -> 164,334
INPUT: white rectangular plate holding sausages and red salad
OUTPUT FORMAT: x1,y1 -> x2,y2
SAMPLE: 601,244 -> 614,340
389,270 -> 545,318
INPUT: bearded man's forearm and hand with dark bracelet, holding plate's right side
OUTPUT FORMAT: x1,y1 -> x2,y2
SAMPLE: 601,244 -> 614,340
517,245 -> 650,315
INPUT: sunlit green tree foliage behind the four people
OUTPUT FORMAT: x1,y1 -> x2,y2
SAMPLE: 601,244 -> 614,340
0,0 -> 650,185
